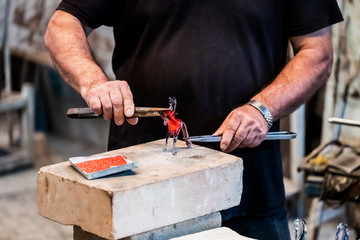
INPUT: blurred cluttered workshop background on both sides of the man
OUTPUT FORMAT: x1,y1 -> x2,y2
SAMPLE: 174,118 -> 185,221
0,0 -> 360,240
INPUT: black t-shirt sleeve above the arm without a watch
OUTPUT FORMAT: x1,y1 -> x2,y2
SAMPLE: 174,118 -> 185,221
57,0 -> 116,29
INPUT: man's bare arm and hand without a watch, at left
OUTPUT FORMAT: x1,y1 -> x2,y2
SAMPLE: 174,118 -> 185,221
45,10 -> 137,125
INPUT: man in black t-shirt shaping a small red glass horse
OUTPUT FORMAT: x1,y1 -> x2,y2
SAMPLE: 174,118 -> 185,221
45,0 -> 342,240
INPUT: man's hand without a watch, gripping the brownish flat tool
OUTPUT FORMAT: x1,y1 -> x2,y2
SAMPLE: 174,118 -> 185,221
81,80 -> 138,125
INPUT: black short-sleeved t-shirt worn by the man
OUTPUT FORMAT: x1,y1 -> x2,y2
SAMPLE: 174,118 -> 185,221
58,0 -> 342,219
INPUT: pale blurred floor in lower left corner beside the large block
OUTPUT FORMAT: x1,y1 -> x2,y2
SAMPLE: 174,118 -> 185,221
0,169 -> 72,240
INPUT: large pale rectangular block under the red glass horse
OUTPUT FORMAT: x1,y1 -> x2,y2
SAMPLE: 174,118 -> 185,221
37,140 -> 243,239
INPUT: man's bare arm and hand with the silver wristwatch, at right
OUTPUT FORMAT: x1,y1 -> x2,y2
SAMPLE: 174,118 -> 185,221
215,27 -> 333,152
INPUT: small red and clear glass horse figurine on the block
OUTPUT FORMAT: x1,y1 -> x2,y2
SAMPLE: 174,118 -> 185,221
160,97 -> 191,155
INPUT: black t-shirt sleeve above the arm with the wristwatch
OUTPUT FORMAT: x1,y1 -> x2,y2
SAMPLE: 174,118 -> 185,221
285,0 -> 343,37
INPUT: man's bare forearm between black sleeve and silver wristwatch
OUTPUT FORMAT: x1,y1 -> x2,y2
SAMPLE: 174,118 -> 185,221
254,27 -> 332,120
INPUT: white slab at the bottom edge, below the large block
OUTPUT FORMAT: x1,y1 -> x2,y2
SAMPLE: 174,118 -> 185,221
171,227 -> 253,240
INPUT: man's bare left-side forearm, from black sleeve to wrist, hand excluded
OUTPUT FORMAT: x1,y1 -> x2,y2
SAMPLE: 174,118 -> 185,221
45,11 -> 108,97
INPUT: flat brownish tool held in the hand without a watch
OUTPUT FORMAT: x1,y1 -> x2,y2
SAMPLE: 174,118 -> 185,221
66,107 -> 170,119
